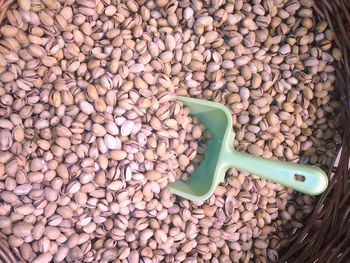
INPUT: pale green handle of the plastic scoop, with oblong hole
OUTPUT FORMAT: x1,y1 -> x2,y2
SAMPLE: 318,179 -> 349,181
229,151 -> 328,195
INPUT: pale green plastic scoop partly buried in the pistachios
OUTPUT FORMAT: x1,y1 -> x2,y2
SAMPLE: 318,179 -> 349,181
169,96 -> 328,201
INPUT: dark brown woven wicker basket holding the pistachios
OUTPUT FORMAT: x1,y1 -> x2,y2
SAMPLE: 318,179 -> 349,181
0,0 -> 350,263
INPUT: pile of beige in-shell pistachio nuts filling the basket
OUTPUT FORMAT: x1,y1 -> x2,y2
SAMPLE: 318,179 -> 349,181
0,0 -> 342,263
